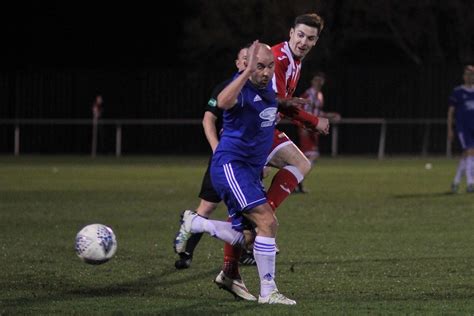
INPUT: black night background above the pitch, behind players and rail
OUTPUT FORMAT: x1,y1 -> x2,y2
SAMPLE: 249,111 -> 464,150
0,0 -> 474,153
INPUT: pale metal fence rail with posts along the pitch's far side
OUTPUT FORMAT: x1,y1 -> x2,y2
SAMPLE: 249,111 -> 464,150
0,118 -> 452,159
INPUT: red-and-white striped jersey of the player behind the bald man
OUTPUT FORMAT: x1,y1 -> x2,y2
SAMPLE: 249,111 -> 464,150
272,42 -> 301,98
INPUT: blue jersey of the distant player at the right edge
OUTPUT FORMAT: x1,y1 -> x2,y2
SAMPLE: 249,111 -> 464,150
449,86 -> 474,130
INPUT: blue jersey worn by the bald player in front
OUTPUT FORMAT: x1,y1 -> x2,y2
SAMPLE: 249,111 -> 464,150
214,75 -> 277,170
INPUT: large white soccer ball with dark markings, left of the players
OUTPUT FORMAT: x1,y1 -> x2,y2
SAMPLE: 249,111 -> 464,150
75,224 -> 117,264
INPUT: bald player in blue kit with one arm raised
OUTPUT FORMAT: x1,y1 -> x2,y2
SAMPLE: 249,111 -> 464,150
175,41 -> 296,305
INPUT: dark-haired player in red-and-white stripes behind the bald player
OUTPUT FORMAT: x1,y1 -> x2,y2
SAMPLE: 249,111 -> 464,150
223,13 -> 329,286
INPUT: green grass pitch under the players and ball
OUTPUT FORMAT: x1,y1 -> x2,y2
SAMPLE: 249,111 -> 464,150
0,156 -> 474,315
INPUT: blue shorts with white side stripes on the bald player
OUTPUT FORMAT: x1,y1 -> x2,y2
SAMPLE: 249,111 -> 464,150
211,159 -> 267,231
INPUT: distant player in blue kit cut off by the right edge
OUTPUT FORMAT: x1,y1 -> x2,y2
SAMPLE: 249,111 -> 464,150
448,65 -> 474,193
